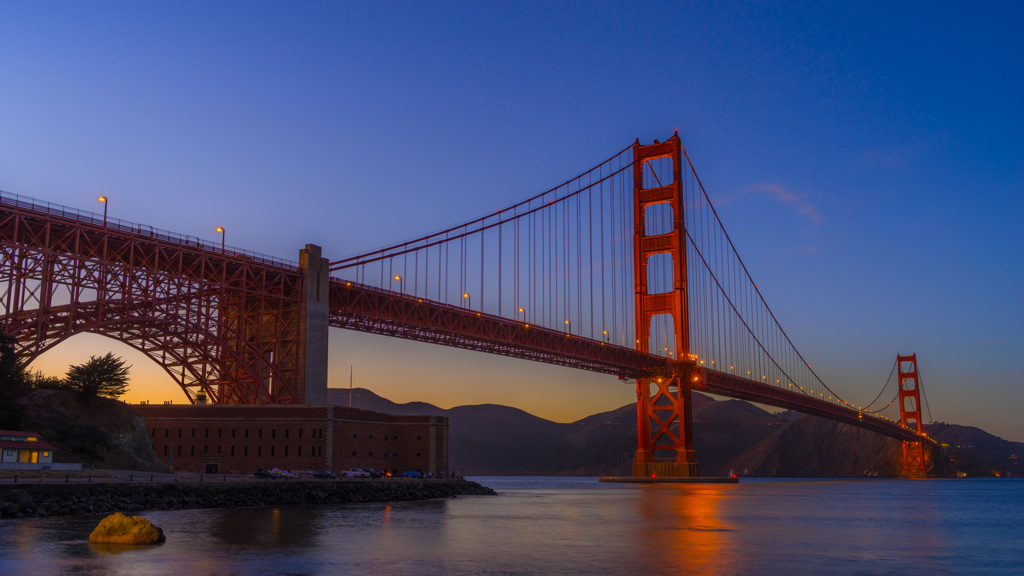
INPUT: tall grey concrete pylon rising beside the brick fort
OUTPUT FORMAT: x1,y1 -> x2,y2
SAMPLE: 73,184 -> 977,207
298,244 -> 330,404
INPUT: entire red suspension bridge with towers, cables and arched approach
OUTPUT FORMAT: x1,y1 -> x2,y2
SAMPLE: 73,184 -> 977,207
0,130 -> 932,478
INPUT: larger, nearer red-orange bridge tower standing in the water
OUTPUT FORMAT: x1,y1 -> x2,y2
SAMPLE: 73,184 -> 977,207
633,131 -> 699,478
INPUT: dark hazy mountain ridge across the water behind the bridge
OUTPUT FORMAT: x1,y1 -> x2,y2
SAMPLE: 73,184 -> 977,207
328,388 -> 1024,478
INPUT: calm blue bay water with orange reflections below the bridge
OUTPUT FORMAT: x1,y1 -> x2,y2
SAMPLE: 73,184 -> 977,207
0,478 -> 1024,576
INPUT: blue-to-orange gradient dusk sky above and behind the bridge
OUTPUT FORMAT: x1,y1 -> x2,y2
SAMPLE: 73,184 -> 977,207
0,1 -> 1024,438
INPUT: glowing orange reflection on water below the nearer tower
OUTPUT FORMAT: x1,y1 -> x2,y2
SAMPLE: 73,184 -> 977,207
637,484 -> 736,576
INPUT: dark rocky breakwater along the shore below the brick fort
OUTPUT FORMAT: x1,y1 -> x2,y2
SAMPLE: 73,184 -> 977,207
0,480 -> 497,518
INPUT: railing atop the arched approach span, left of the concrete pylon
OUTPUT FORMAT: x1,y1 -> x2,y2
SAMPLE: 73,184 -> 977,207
0,190 -> 299,270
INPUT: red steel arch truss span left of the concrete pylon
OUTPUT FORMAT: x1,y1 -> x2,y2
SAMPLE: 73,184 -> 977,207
0,195 -> 302,404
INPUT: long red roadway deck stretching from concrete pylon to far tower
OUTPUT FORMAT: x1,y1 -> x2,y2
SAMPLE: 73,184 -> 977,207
330,279 -> 934,444
